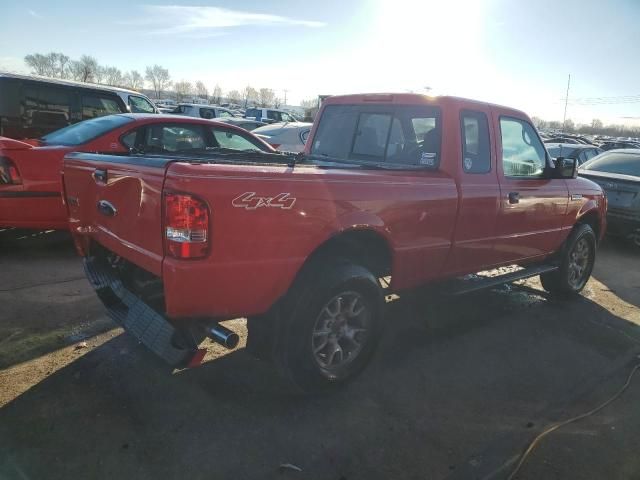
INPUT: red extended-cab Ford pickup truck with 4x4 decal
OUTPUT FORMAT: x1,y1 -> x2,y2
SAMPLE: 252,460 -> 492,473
63,94 -> 606,390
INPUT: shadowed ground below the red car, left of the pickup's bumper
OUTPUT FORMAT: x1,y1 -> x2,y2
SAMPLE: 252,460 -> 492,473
0,229 -> 114,370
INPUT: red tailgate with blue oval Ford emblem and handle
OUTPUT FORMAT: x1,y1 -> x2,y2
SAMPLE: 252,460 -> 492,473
63,153 -> 171,276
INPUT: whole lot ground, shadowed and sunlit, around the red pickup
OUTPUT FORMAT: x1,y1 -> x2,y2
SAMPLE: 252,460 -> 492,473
0,231 -> 640,480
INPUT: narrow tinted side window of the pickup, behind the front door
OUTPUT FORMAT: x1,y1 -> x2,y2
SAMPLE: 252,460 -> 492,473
460,111 -> 491,173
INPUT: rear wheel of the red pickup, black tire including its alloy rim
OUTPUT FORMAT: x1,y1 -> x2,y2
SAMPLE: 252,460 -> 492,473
274,260 -> 384,392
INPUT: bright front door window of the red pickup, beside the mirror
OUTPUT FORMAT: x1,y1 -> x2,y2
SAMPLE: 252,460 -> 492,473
500,117 -> 547,178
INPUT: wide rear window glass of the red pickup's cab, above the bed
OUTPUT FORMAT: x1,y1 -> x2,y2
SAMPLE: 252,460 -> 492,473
311,105 -> 441,168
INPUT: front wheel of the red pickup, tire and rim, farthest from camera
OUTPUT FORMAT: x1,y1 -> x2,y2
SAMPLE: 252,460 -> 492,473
540,224 -> 597,296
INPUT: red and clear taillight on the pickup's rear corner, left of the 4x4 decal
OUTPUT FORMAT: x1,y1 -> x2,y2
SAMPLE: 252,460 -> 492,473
164,193 -> 209,258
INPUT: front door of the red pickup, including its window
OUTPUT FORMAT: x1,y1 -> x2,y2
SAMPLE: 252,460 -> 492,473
493,109 -> 569,263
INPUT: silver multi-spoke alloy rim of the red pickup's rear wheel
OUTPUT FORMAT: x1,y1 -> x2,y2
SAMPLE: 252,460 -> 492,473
311,291 -> 371,374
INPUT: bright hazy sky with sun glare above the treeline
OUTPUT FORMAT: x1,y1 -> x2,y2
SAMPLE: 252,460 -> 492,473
0,0 -> 640,126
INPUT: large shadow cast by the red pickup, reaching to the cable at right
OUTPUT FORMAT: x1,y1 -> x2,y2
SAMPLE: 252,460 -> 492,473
0,286 -> 640,480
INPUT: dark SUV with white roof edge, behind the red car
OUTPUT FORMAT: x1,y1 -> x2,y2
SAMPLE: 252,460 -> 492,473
0,72 -> 158,139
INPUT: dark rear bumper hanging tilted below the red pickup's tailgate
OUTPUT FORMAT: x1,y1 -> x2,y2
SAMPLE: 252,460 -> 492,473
84,257 -> 196,366
